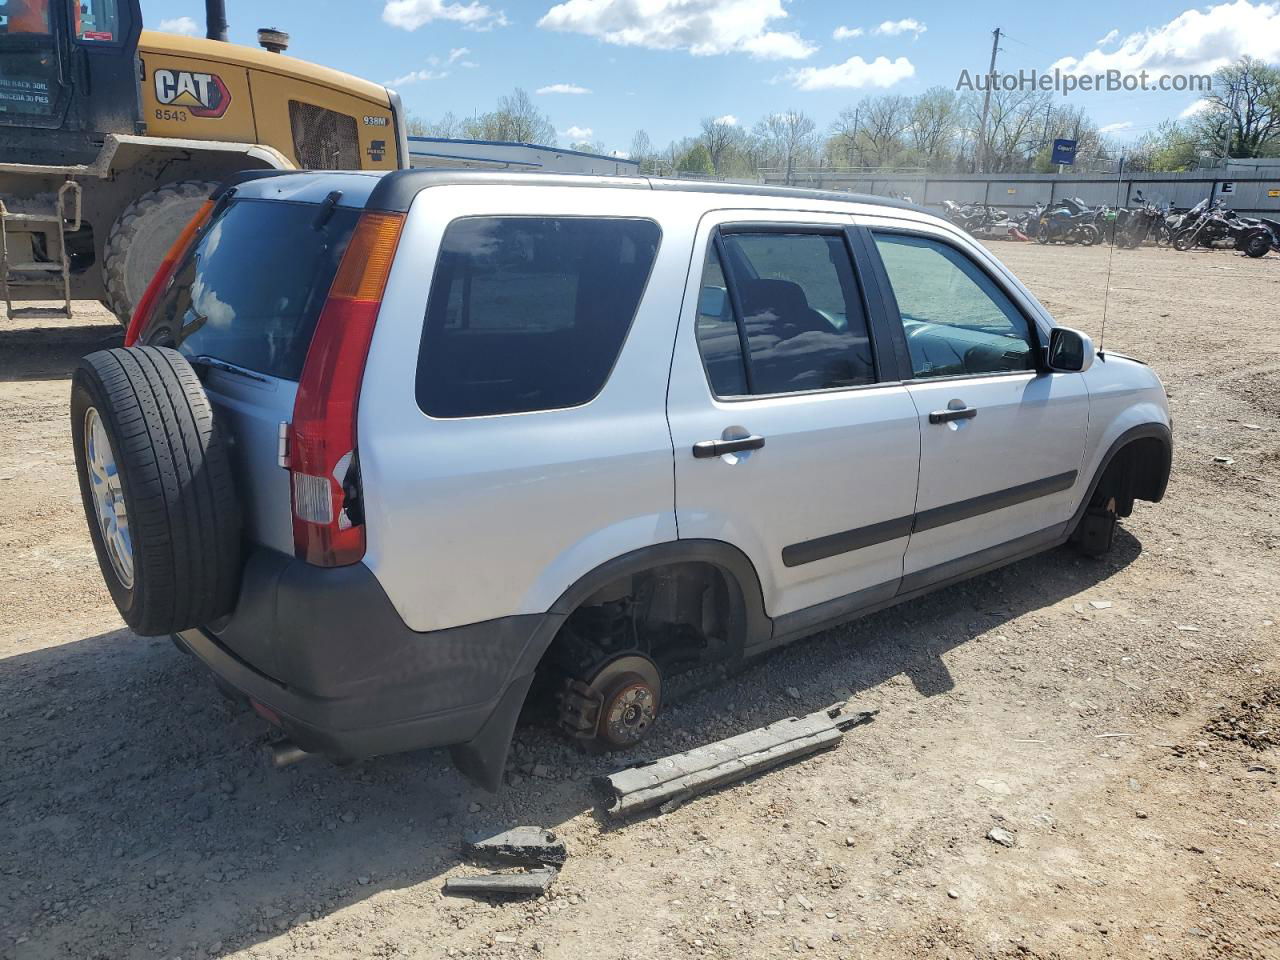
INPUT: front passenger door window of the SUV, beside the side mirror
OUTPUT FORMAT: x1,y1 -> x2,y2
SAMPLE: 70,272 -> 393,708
874,233 -> 1037,378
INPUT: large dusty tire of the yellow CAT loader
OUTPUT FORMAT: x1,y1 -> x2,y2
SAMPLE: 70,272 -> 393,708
102,180 -> 218,325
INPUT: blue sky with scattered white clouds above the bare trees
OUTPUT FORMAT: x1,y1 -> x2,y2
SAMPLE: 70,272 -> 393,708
142,0 -> 1280,150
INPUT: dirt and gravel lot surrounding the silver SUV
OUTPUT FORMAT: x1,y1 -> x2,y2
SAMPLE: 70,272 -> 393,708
0,243 -> 1280,960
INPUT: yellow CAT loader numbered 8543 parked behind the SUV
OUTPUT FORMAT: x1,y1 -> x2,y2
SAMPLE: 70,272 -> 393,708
0,0 -> 408,321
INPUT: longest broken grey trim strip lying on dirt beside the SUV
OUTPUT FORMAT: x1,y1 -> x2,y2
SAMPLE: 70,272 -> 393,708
595,704 -> 877,818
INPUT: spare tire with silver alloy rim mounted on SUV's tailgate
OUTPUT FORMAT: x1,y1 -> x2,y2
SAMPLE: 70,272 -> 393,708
72,347 -> 241,636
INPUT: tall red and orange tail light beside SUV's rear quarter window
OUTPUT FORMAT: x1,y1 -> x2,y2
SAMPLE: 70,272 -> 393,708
289,214 -> 404,567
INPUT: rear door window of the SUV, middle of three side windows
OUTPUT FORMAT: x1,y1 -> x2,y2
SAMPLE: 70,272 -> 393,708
696,233 -> 876,397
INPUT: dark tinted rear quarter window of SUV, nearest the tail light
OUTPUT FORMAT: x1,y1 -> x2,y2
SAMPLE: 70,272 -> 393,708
417,216 -> 659,417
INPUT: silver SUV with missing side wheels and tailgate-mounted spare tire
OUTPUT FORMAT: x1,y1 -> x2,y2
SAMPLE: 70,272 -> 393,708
72,170 -> 1171,788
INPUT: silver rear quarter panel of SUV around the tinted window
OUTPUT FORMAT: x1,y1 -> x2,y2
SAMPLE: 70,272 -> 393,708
358,186 -> 696,630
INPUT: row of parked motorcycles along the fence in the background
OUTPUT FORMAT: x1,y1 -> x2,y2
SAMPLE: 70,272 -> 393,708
942,191 -> 1280,257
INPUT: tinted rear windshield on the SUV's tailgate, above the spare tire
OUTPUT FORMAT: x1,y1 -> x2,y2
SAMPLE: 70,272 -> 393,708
142,200 -> 360,380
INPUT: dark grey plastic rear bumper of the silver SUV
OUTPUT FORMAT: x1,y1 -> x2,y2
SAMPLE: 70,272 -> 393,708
178,548 -> 563,788
